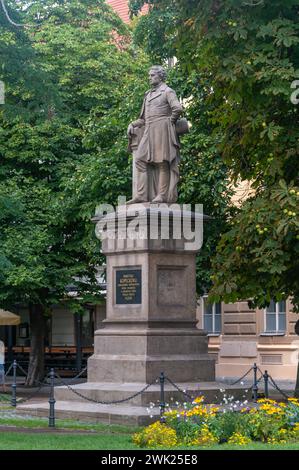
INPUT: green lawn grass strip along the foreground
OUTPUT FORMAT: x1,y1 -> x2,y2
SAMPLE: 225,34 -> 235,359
0,405 -> 299,451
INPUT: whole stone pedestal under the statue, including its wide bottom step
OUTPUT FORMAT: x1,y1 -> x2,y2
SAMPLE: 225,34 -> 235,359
18,204 -> 245,425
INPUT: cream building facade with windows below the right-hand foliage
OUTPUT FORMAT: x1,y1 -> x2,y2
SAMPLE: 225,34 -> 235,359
197,298 -> 299,381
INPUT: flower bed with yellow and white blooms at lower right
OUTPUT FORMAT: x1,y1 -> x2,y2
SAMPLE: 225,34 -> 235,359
133,397 -> 299,448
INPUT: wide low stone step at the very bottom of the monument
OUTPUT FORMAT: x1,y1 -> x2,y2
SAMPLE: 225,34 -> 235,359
16,382 -> 250,426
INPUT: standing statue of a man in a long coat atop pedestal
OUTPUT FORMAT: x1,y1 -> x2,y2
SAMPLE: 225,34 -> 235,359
128,66 -> 183,204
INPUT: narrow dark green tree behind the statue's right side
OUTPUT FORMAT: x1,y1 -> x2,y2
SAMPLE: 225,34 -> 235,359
169,67 -> 234,296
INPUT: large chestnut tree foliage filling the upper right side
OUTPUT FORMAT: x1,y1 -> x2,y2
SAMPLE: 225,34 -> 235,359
130,0 -> 299,310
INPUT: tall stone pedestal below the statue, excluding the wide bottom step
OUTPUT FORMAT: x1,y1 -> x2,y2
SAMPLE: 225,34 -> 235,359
88,204 -> 215,384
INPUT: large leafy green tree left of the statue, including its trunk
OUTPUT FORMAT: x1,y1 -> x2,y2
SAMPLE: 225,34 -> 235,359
0,0 -> 150,384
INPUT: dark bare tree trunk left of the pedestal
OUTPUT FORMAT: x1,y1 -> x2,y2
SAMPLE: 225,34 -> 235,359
25,305 -> 46,387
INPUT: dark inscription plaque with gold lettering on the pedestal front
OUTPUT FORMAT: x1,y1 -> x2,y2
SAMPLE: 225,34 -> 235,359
115,269 -> 141,304
